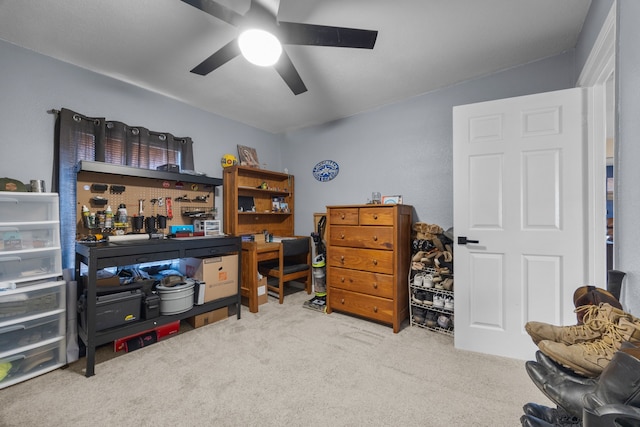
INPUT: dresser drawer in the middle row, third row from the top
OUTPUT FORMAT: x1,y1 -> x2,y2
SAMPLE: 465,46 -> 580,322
327,246 -> 394,274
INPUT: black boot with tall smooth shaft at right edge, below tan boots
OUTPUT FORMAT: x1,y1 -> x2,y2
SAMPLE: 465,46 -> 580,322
582,349 -> 640,409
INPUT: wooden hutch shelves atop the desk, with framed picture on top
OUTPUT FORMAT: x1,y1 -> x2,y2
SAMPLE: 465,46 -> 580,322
223,166 -> 295,236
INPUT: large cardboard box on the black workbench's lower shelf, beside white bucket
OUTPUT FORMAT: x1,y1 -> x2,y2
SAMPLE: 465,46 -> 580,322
180,254 -> 238,302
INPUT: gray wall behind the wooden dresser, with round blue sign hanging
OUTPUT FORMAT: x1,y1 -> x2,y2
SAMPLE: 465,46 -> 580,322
282,50 -> 575,235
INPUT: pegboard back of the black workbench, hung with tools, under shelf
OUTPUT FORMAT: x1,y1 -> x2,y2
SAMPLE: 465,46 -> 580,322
76,162 -> 221,238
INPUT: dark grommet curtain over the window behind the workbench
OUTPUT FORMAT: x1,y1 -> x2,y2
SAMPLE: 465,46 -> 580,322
52,108 -> 195,268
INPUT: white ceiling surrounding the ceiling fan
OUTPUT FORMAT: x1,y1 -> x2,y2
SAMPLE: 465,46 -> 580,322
0,0 -> 591,133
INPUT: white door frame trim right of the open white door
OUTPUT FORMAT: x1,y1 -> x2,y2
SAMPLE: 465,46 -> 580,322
576,0 -> 617,287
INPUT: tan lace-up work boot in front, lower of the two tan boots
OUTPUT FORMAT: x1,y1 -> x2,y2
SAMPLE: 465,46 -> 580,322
538,317 -> 640,378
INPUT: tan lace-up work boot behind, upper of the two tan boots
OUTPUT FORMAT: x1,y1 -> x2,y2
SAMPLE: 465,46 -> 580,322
524,303 -> 633,345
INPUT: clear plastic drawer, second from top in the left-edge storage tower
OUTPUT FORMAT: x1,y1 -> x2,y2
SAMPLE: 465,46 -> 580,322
0,222 -> 60,252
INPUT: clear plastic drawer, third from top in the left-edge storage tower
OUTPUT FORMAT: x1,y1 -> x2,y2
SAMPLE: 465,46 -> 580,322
0,249 -> 62,286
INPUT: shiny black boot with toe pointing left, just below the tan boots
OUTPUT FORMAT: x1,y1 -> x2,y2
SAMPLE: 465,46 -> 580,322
525,361 -> 598,418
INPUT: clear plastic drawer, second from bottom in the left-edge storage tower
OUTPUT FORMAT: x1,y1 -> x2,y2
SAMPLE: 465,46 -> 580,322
0,309 -> 66,354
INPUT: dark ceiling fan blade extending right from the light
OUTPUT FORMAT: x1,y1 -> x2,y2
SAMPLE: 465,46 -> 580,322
279,22 -> 378,49
